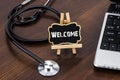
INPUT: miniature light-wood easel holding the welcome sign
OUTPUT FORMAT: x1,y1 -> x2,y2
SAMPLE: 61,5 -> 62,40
48,12 -> 82,55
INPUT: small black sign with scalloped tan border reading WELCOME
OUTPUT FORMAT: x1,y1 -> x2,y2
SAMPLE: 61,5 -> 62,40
48,22 -> 81,45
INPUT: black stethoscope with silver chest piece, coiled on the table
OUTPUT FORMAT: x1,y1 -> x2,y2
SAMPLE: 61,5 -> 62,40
5,0 -> 60,76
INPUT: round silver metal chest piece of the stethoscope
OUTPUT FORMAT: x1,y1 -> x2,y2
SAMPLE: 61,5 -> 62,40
38,60 -> 60,76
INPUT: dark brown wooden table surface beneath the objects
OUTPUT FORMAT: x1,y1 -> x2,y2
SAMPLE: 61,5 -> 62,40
0,0 -> 120,80
